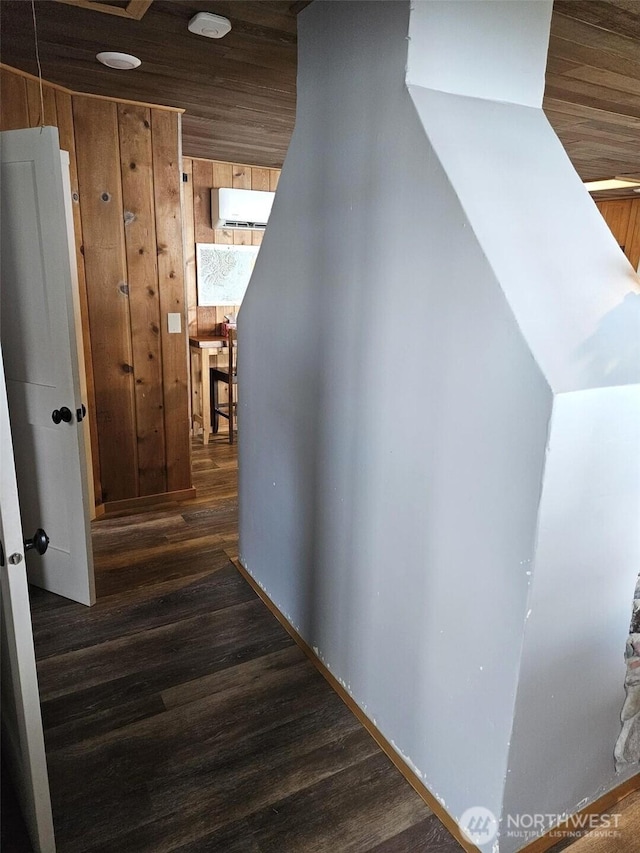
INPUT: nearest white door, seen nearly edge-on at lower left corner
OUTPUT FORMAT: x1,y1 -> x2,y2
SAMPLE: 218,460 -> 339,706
0,340 -> 55,853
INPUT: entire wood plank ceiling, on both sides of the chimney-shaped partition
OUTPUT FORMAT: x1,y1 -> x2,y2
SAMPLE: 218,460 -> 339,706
0,0 -> 640,194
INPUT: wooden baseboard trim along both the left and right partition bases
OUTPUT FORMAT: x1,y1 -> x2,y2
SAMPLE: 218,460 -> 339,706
232,558 -> 640,853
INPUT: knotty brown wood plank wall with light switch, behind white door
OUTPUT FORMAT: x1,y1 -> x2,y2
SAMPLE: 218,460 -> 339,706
0,68 -> 191,504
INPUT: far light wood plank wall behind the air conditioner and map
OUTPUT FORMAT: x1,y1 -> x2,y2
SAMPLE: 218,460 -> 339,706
182,157 -> 280,336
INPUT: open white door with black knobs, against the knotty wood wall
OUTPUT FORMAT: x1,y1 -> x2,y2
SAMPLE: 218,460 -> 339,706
0,127 -> 95,604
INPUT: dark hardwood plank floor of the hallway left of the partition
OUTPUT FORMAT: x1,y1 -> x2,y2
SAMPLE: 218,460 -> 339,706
3,435 -> 462,853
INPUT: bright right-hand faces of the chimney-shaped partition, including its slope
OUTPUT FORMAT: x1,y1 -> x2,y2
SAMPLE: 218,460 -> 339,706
407,2 -> 640,850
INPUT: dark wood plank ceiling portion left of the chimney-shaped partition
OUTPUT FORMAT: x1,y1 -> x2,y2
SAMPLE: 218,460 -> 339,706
0,0 -> 298,167
